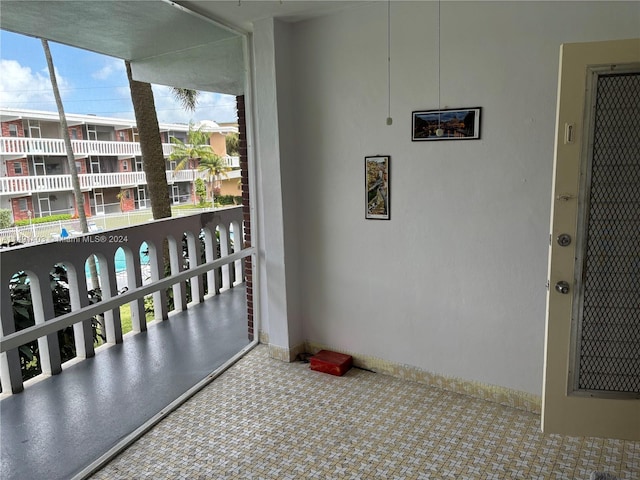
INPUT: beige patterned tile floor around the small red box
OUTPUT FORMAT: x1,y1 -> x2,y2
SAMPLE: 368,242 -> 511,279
91,346 -> 640,480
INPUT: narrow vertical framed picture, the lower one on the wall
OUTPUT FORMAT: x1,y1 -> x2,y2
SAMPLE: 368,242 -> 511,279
364,155 -> 391,220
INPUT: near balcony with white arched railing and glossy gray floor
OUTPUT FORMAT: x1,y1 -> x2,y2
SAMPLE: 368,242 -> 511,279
0,207 -> 255,478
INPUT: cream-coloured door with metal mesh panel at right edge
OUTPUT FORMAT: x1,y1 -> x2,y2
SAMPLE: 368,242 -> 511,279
542,39 -> 640,440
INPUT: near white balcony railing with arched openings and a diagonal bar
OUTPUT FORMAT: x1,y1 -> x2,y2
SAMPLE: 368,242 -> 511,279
0,207 -> 255,394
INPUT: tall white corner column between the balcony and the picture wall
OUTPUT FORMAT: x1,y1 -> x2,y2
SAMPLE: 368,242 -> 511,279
253,18 -> 304,360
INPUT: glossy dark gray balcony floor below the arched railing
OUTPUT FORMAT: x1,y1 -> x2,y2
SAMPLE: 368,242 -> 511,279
0,287 -> 250,480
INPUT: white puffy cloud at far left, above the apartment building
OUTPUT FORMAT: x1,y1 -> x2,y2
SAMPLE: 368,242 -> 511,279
0,59 -> 69,110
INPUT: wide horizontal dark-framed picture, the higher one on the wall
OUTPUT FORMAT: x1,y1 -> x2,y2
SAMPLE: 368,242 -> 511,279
411,107 -> 480,142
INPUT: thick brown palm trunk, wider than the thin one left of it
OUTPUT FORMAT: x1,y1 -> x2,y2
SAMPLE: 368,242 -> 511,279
125,61 -> 171,220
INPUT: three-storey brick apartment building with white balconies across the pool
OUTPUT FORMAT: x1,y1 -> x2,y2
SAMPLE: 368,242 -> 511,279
0,108 -> 240,221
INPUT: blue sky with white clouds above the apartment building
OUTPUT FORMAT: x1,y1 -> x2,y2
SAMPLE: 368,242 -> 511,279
0,30 -> 236,123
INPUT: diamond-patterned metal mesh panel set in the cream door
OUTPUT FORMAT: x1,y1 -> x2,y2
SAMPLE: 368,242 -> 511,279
577,73 -> 640,393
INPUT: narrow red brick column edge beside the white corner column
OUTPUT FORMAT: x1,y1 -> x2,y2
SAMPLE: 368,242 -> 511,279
236,95 -> 256,340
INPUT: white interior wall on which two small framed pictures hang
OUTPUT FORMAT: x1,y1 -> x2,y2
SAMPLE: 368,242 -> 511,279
254,1 -> 640,395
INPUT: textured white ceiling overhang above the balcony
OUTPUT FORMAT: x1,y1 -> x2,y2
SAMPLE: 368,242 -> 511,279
0,0 -> 362,95
